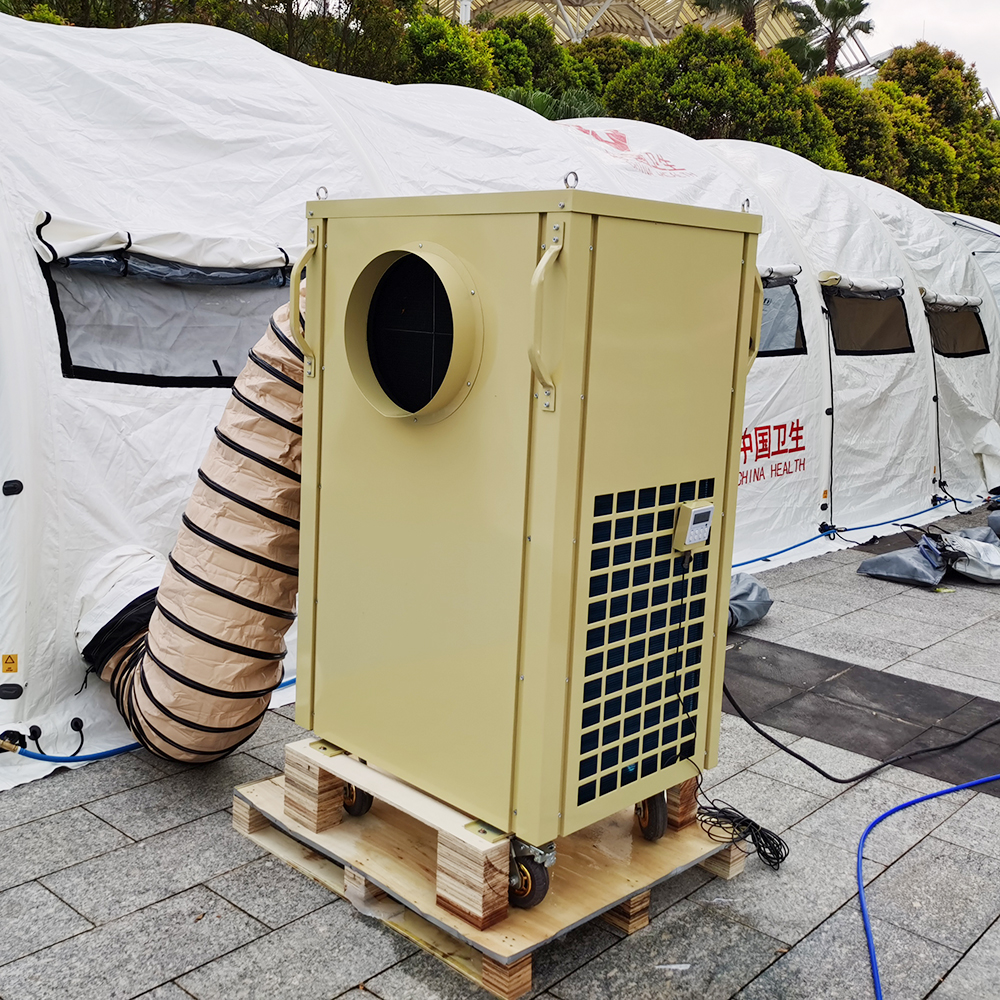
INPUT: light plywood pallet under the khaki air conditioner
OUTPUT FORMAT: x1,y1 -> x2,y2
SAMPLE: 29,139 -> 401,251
233,741 -> 745,1000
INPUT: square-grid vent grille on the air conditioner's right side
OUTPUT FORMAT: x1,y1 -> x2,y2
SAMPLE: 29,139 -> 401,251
577,479 -> 715,805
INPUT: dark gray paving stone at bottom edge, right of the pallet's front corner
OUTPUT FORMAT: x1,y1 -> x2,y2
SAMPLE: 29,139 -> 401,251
549,900 -> 783,1000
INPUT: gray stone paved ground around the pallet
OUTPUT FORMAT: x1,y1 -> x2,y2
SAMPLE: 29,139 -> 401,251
0,516 -> 1000,1000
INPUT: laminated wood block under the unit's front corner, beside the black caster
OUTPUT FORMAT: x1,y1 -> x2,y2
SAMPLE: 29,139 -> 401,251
437,831 -> 510,930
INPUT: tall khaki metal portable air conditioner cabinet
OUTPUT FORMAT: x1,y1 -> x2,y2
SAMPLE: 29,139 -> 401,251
296,190 -> 760,868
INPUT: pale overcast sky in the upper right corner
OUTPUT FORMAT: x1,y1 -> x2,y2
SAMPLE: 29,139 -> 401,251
858,0 -> 1000,98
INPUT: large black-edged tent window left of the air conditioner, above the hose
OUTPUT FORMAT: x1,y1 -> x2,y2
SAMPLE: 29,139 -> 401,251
42,258 -> 288,386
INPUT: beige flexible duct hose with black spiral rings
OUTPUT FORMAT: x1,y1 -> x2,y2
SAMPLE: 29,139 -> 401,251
102,292 -> 302,762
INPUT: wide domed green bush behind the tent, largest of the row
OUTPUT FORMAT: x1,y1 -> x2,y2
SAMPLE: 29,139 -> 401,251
604,25 -> 844,170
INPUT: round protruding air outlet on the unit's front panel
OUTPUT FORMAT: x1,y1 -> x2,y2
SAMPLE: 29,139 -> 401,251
345,250 -> 483,423
